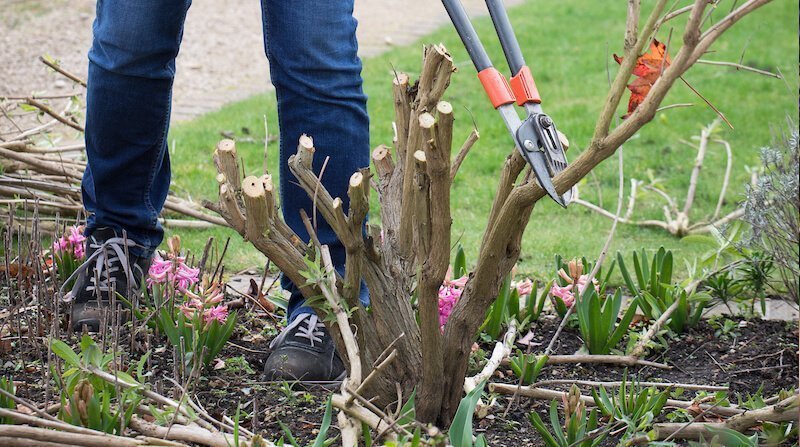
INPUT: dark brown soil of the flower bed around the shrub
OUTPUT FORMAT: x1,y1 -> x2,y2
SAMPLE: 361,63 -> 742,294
0,304 -> 798,447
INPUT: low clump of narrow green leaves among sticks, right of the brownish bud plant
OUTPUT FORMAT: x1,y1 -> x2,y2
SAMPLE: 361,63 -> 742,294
592,372 -> 670,438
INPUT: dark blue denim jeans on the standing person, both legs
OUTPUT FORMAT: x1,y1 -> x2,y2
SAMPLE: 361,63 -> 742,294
82,0 -> 369,321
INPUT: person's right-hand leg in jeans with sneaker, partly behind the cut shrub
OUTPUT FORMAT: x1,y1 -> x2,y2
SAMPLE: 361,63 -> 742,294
262,0 -> 369,382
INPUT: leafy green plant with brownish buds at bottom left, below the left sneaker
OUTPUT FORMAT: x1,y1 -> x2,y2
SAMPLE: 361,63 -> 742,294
51,335 -> 146,434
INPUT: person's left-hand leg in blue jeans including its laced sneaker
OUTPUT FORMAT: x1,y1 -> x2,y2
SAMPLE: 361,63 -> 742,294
70,0 -> 191,330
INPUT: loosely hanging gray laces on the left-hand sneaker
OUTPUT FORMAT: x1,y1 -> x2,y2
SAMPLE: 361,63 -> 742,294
59,236 -> 143,301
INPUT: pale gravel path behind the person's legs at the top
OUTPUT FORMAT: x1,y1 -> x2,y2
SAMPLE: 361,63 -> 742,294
0,0 -> 523,120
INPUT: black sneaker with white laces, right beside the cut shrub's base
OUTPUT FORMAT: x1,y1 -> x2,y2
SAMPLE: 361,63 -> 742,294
264,314 -> 347,389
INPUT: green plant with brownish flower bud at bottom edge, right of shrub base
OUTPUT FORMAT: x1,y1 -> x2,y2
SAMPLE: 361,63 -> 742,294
528,385 -> 606,447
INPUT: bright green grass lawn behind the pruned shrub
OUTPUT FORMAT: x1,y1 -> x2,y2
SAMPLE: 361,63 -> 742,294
170,0 -> 798,284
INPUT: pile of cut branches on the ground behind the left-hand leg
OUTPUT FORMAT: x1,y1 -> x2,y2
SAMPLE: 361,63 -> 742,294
0,58 -> 226,231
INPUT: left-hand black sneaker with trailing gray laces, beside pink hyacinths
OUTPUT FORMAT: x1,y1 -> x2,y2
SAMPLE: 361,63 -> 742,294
64,227 -> 150,332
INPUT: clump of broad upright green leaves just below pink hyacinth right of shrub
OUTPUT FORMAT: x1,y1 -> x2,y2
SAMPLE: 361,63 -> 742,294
575,287 -> 638,354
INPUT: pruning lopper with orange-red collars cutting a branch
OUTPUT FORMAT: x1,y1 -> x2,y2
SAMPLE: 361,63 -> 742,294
442,0 -> 572,208
